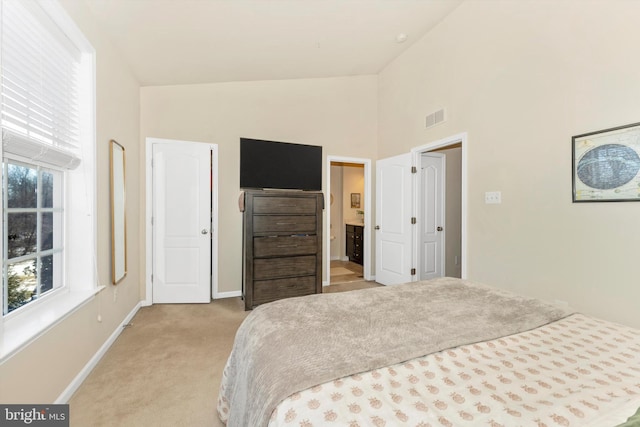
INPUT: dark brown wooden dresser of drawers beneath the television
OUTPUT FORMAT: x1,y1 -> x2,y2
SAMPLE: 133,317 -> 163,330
242,190 -> 324,310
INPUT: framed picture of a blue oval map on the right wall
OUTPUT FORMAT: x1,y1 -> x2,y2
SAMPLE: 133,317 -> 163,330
571,123 -> 640,202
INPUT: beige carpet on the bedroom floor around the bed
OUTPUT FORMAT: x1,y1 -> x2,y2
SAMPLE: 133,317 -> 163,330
69,282 -> 380,427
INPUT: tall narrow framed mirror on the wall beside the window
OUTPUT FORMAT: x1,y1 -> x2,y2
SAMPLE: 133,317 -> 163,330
110,140 -> 127,285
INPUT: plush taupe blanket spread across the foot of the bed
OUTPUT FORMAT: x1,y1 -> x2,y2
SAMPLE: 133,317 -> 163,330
218,278 -> 571,427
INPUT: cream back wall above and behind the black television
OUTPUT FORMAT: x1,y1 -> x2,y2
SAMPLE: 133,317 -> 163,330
140,76 -> 377,292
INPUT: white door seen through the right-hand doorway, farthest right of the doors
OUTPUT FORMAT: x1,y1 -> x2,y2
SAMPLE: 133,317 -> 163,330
418,153 -> 445,280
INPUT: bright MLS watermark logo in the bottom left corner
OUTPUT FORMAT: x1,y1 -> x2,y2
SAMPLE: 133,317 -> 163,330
0,405 -> 69,427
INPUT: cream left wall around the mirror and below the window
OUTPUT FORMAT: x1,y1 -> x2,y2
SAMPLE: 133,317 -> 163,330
0,0 -> 144,403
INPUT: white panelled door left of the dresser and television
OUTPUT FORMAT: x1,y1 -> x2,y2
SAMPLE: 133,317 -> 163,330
152,141 -> 212,303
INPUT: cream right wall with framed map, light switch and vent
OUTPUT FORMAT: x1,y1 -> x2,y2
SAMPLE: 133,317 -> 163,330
378,0 -> 640,327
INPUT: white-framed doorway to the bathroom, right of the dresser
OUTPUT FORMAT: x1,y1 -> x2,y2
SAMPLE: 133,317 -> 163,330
323,156 -> 371,286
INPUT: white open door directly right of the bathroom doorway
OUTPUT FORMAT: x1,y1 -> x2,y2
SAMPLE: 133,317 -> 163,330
375,153 -> 412,285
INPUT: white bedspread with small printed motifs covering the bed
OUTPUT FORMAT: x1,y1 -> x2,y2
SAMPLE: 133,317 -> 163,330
269,314 -> 640,427
